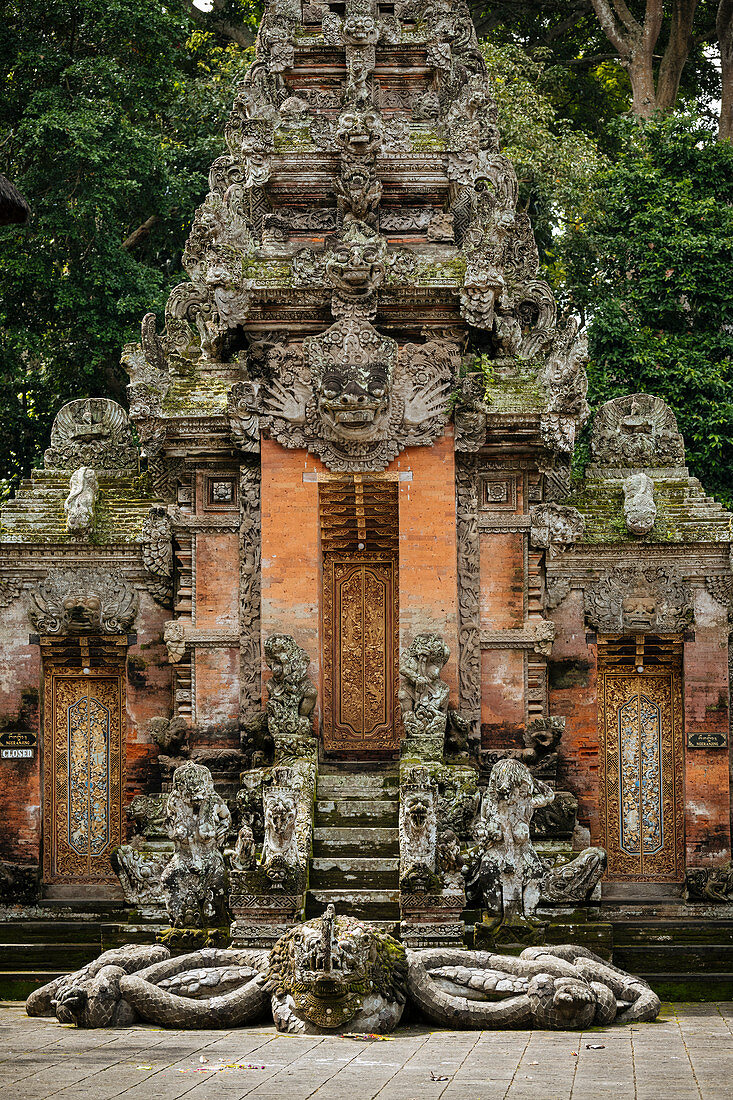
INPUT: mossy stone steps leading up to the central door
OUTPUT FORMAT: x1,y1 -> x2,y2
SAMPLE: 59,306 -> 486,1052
306,761 -> 400,931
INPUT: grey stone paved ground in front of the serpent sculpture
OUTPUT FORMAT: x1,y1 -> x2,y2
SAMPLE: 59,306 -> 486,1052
0,1002 -> 733,1100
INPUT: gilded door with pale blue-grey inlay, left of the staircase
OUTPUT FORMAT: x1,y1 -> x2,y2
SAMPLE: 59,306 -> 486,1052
44,671 -> 123,883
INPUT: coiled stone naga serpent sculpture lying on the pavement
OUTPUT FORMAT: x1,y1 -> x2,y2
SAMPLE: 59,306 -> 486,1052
26,905 -> 660,1034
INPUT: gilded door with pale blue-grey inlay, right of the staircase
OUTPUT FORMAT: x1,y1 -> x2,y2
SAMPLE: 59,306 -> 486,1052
599,670 -> 685,882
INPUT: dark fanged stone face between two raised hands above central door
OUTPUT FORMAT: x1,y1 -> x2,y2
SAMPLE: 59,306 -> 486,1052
316,363 -> 390,442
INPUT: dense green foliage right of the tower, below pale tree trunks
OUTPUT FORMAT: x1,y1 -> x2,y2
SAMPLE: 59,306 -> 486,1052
566,116 -> 733,503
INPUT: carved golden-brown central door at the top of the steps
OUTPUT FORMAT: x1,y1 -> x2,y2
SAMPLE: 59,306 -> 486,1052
322,554 -> 398,752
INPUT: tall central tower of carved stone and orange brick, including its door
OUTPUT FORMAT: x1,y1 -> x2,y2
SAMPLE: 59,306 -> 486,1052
121,0 -> 588,770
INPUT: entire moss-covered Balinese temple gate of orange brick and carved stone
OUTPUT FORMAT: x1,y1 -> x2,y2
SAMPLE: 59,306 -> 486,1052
0,0 -> 733,997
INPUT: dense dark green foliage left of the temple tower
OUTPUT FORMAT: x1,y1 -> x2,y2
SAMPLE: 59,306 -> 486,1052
0,0 -> 247,491
